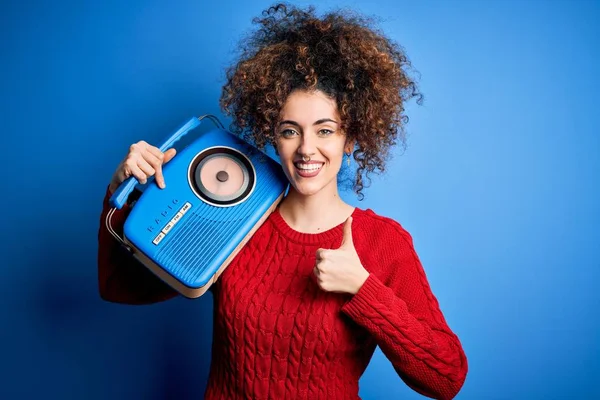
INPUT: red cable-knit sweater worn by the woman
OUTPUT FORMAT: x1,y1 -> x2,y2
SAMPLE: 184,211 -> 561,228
98,188 -> 467,400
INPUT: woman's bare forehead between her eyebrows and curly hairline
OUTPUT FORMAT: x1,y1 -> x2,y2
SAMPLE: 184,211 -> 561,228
281,90 -> 339,122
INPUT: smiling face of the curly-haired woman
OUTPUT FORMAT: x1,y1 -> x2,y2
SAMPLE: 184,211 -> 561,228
276,91 -> 351,196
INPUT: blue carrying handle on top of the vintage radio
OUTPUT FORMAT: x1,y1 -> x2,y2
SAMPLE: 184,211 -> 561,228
106,114 -> 225,250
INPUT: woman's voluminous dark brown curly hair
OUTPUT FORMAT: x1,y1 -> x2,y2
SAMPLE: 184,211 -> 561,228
220,4 -> 423,198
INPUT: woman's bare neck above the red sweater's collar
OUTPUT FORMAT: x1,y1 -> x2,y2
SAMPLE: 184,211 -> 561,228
279,180 -> 354,233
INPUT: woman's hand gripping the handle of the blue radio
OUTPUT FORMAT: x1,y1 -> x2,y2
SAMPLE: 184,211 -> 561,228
109,140 -> 176,193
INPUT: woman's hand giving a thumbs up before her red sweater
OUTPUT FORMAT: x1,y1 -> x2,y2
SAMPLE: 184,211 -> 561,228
313,217 -> 369,294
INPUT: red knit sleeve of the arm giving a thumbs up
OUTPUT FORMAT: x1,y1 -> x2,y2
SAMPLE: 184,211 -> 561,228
342,223 -> 468,399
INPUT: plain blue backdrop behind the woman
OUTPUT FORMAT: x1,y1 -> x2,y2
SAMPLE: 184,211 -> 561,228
0,0 -> 600,400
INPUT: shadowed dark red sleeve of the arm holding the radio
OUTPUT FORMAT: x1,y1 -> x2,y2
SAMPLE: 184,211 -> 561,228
98,189 -> 177,304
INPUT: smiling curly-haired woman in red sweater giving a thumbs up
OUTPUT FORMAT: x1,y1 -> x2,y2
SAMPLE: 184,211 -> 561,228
99,5 -> 467,399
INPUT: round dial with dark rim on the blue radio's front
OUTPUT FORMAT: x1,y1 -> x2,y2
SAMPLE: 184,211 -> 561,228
189,147 -> 256,207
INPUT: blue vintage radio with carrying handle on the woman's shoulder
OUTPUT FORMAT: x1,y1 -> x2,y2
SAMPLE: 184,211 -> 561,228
106,116 -> 288,298
